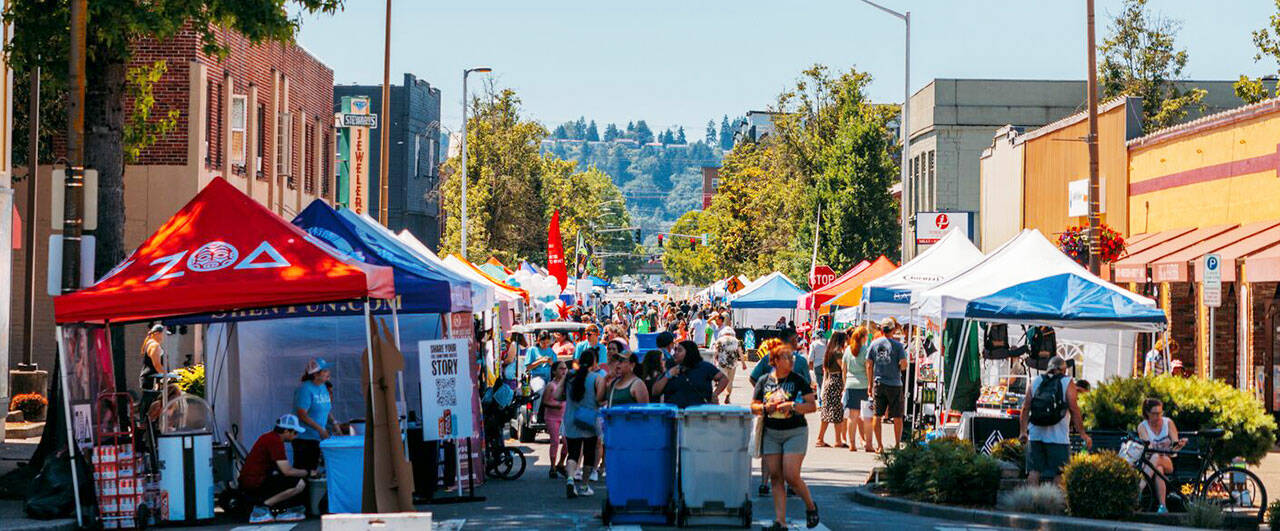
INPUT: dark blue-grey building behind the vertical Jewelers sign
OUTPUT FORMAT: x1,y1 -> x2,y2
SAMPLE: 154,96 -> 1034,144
332,73 -> 442,248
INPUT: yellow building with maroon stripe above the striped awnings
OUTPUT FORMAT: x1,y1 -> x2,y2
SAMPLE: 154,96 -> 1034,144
1128,100 -> 1280,411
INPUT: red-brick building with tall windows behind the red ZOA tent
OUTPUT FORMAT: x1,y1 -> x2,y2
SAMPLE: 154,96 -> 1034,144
9,23 -> 334,381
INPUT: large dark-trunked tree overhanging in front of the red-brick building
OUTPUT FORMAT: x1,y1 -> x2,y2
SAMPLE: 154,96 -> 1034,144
4,0 -> 342,286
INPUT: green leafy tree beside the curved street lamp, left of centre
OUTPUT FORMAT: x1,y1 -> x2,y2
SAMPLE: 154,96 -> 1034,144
442,87 -> 634,274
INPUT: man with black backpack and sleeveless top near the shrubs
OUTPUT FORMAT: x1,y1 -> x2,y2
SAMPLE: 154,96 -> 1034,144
1019,356 -> 1093,485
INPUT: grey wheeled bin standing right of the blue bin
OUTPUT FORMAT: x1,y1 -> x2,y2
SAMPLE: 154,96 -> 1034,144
675,406 -> 751,527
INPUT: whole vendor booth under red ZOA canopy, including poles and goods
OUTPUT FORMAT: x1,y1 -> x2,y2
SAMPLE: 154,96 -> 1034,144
54,178 -> 417,527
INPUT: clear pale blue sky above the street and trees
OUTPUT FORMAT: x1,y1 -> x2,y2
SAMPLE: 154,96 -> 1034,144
298,0 -> 1276,138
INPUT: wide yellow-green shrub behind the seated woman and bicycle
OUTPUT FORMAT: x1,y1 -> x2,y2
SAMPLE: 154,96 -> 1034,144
1080,375 -> 1276,466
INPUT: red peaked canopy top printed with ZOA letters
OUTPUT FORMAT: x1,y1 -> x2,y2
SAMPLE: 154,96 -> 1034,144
54,178 -> 394,322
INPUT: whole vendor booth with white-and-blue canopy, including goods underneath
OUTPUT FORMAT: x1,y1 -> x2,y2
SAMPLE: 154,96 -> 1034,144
911,229 -> 1166,445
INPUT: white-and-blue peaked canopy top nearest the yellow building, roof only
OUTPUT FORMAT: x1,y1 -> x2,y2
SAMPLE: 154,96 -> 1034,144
911,229 -> 1166,331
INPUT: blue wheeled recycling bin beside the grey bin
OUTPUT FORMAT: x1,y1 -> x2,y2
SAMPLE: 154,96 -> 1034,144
602,404 -> 680,526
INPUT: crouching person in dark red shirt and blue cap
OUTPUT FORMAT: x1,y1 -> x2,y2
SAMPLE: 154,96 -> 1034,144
239,415 -> 315,523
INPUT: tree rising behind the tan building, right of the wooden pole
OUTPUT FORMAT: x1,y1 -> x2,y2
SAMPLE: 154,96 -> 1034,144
1098,0 -> 1206,132
